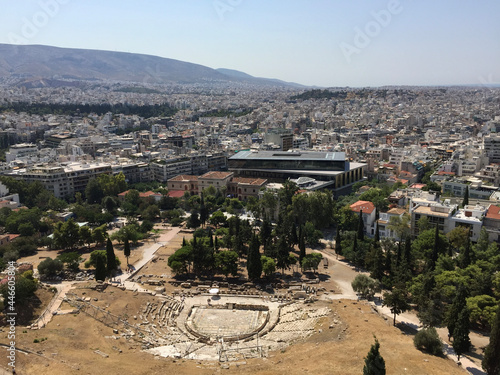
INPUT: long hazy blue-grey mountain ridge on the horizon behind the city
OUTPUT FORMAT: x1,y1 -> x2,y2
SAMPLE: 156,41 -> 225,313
0,44 -> 305,88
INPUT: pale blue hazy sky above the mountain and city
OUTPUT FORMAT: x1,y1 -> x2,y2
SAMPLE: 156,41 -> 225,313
0,0 -> 500,87
